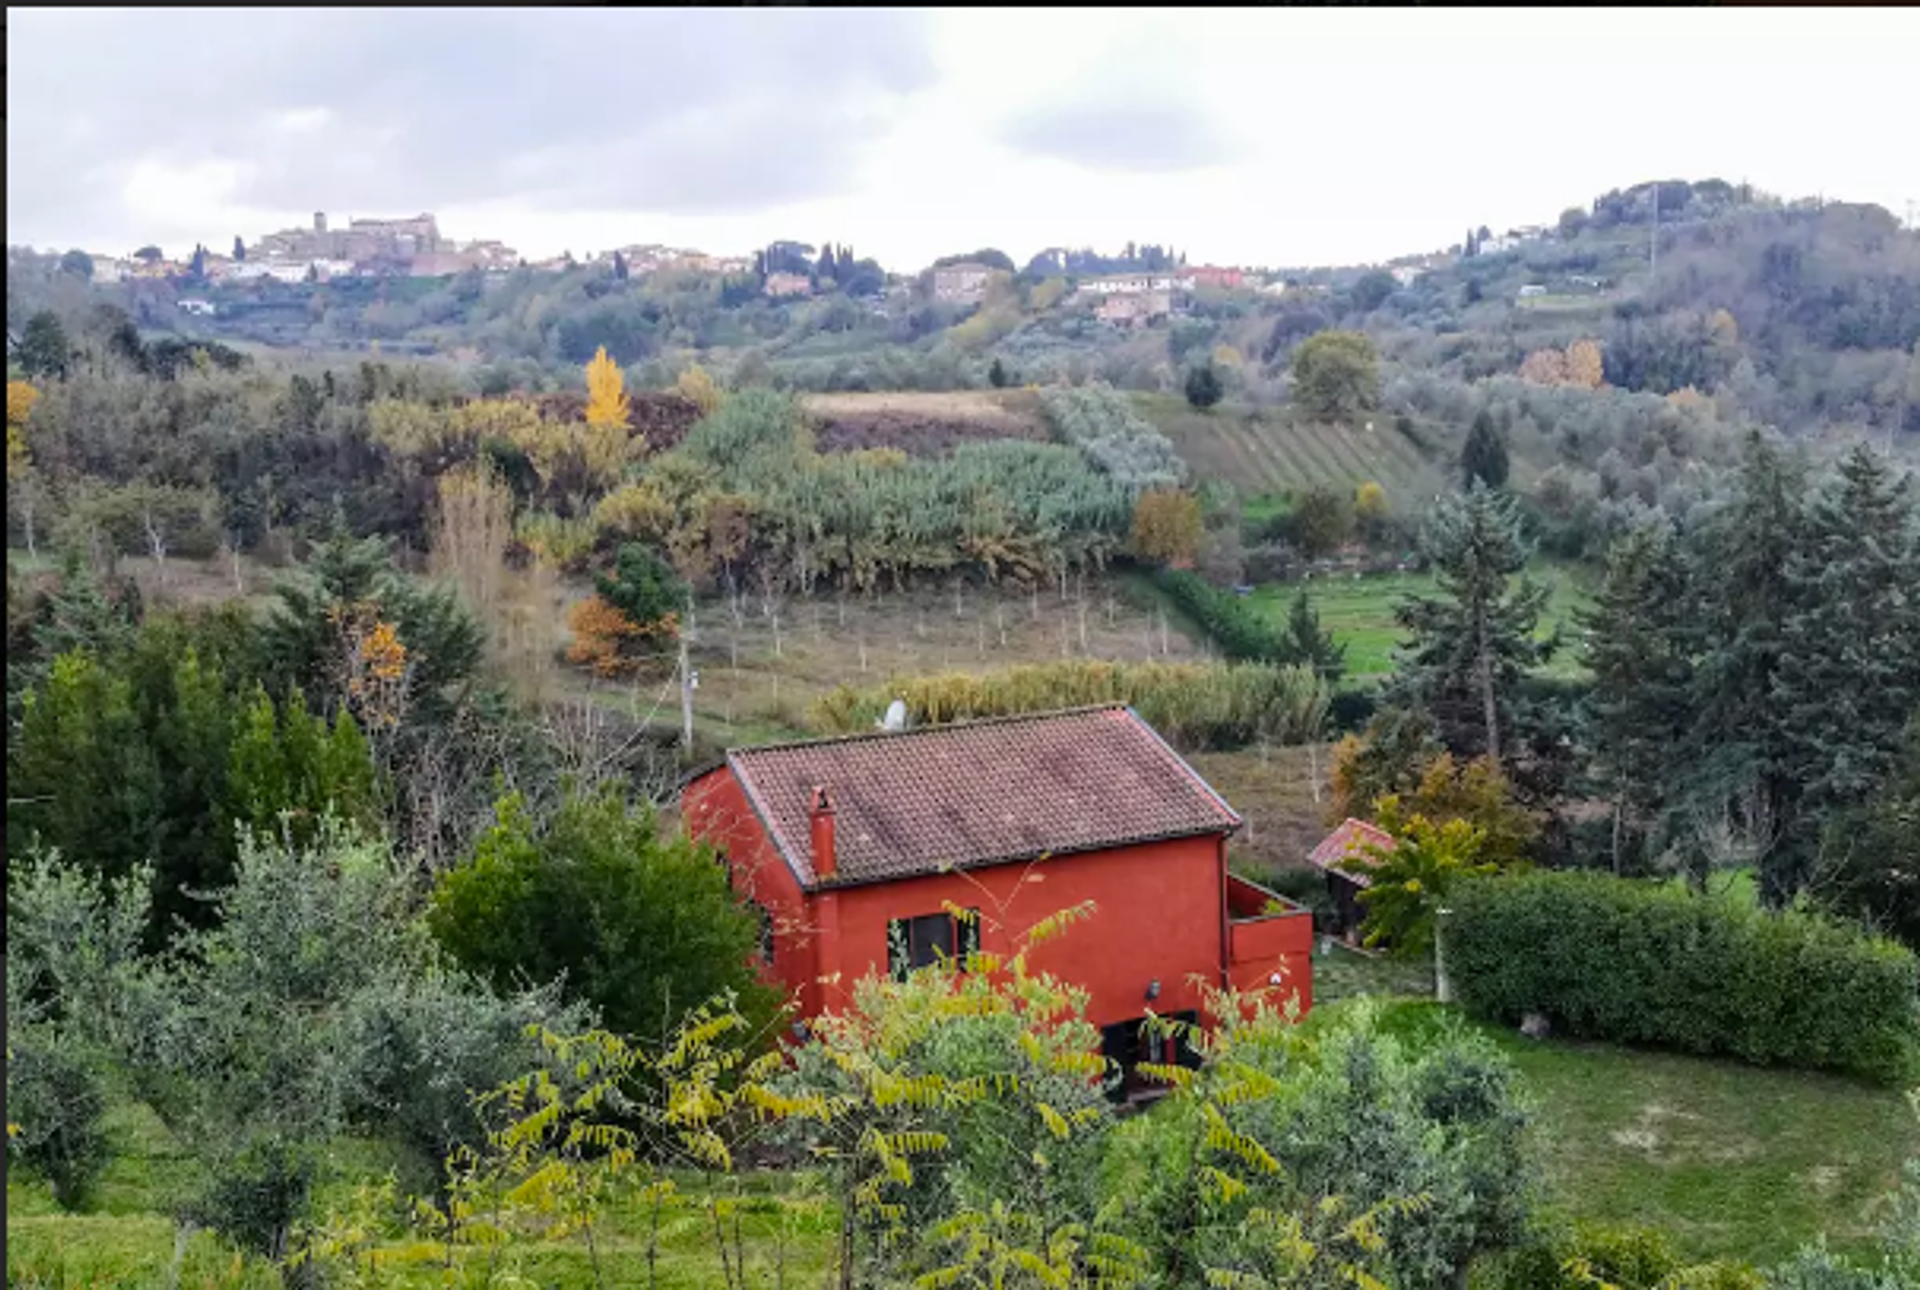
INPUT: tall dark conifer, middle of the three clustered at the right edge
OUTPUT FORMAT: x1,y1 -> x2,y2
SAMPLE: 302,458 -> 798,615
1684,432 -> 1812,906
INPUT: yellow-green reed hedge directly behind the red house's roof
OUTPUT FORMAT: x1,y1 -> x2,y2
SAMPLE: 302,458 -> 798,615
812,660 -> 1327,751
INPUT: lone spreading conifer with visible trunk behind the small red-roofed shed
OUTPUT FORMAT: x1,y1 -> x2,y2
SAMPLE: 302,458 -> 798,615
1394,482 -> 1548,760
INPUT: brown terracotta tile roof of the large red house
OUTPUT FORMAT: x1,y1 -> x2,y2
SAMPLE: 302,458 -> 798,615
728,706 -> 1240,887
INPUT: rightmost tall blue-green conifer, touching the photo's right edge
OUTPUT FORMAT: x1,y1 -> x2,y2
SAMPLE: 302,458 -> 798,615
1770,445 -> 1920,835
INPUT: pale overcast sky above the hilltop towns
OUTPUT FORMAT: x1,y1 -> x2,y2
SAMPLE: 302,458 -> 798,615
6,8 -> 1920,271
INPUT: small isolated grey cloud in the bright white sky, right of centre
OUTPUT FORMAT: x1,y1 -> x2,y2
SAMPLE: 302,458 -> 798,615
998,96 -> 1244,173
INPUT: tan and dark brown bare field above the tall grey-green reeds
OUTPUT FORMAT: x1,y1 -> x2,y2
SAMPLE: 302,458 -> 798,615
801,390 -> 1048,457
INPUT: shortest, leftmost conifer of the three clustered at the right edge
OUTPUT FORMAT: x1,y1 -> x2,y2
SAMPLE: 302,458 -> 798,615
1580,524 -> 1693,873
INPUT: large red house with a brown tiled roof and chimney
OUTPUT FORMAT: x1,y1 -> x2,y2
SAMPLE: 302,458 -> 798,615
682,706 -> 1313,1063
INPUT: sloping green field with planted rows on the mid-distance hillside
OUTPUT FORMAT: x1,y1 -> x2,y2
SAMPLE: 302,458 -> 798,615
1135,394 -> 1444,507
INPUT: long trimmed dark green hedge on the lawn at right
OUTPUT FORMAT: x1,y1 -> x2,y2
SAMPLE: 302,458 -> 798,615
1446,873 -> 1920,1083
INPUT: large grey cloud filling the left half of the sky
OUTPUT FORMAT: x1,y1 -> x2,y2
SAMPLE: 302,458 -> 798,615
8,10 -> 933,244
